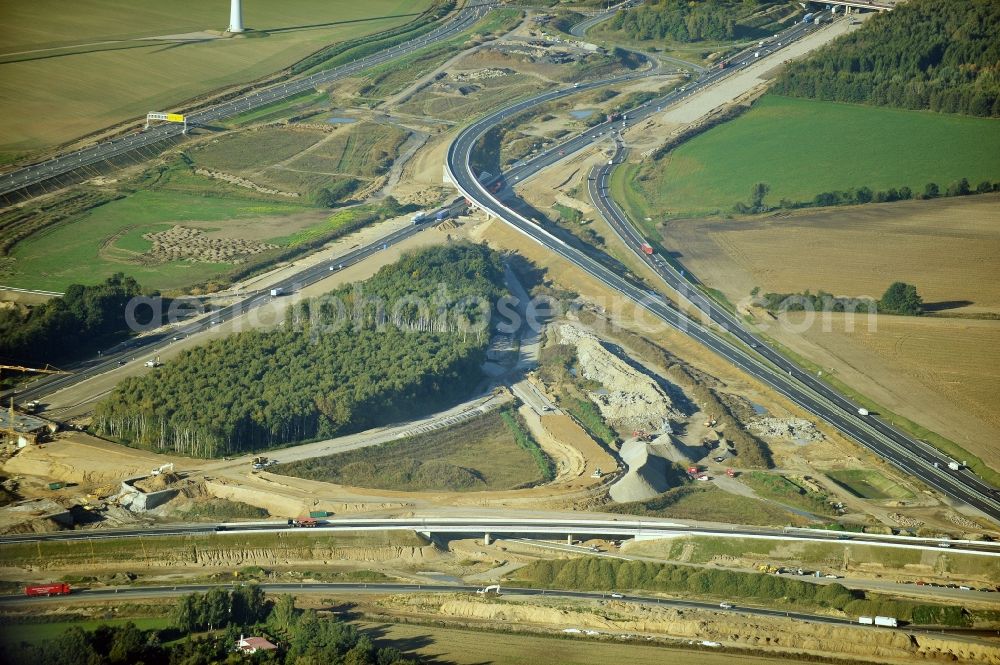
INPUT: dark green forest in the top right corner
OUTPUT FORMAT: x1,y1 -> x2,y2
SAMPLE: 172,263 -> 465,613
772,0 -> 1000,117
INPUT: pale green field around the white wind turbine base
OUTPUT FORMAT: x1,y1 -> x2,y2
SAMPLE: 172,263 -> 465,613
0,0 -> 431,152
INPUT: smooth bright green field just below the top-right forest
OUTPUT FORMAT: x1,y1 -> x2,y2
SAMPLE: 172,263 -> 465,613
612,95 -> 1000,220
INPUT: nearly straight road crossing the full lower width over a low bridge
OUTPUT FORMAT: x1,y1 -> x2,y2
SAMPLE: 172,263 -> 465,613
0,516 -> 1000,557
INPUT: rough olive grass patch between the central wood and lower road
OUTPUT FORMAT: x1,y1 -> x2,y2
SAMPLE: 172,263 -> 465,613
273,412 -> 542,492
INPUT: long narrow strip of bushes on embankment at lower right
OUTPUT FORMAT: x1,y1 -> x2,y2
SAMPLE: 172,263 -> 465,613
518,557 -> 969,626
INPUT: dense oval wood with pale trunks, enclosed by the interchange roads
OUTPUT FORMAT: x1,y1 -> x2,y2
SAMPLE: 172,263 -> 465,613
93,243 -> 504,457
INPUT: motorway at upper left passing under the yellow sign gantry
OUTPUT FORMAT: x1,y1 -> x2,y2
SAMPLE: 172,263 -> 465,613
0,0 -> 496,203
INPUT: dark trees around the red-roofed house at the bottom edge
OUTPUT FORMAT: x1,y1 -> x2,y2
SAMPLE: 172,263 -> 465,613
8,585 -> 420,665
